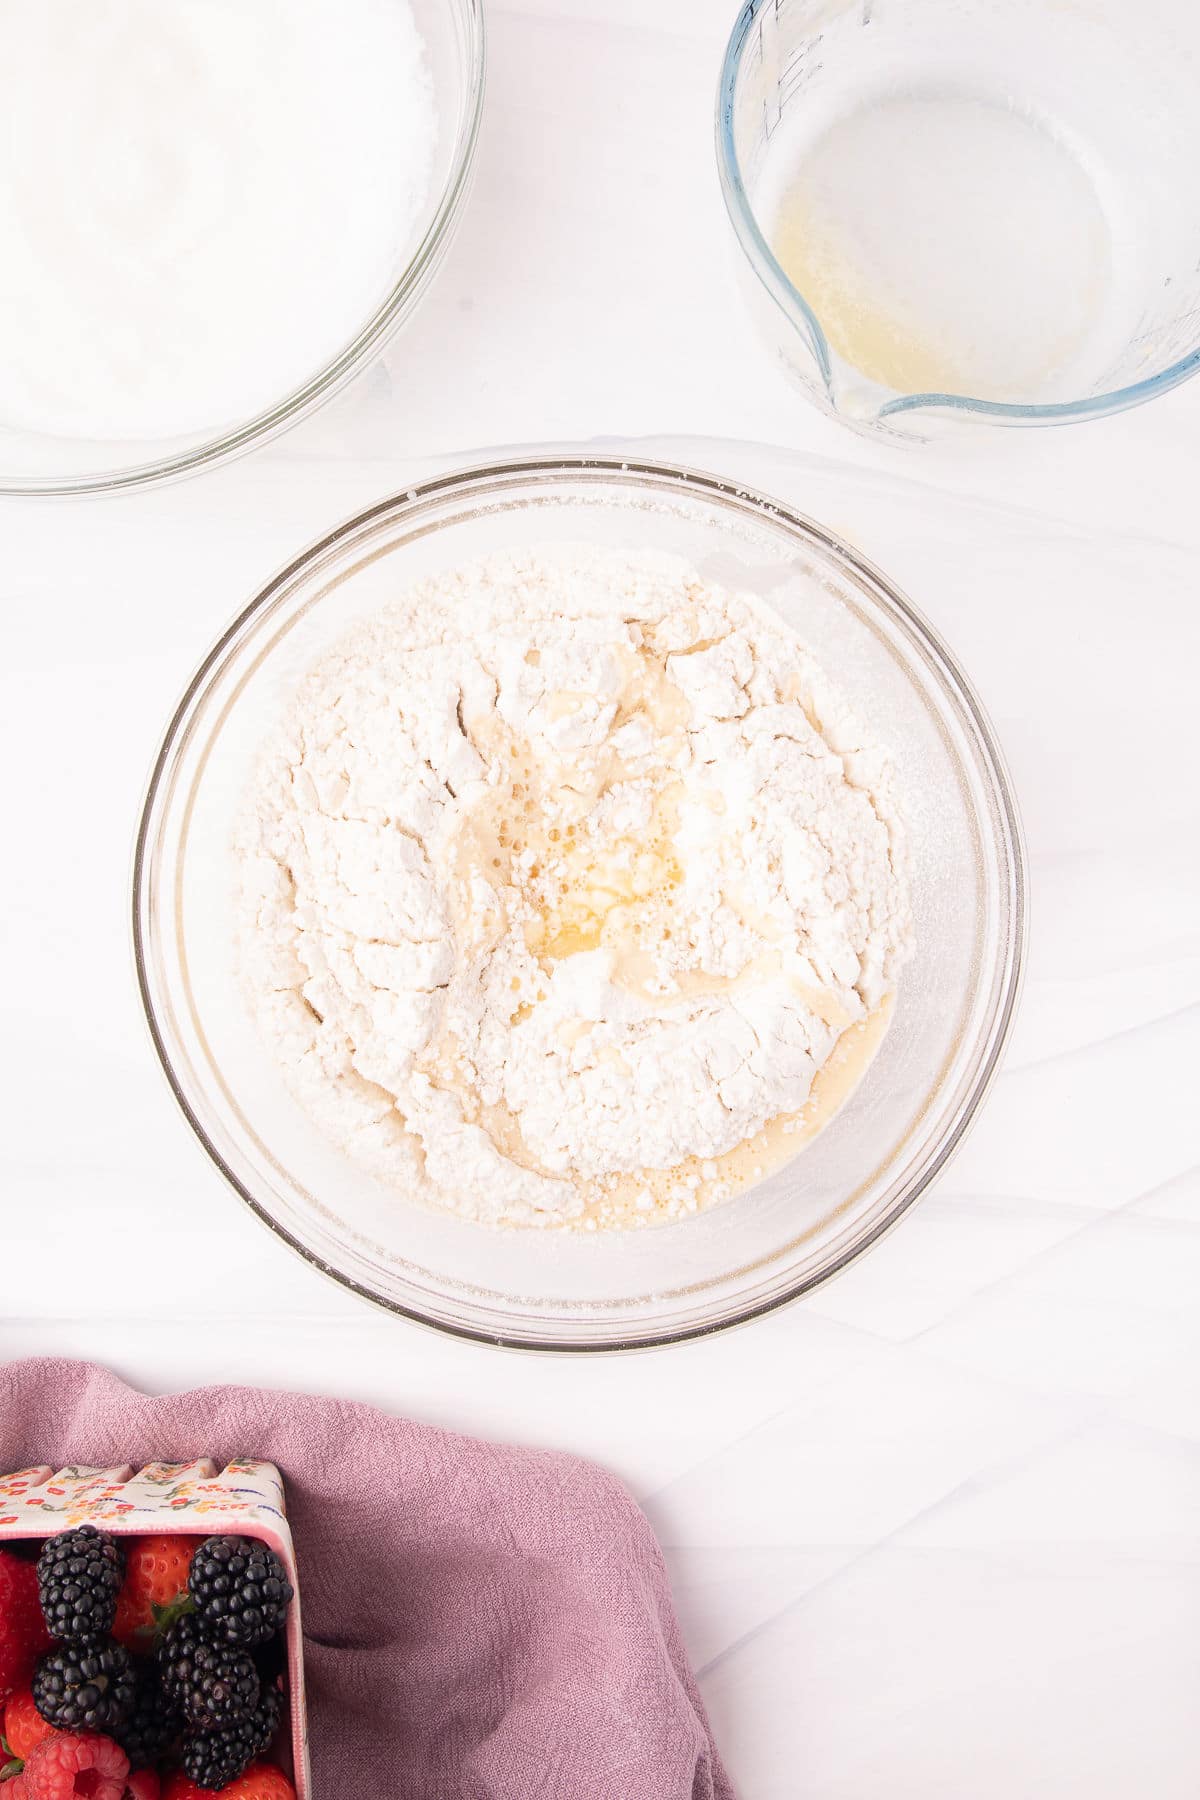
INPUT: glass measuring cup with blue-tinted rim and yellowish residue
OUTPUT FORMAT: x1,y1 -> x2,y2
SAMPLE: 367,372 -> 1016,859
716,0 -> 1200,439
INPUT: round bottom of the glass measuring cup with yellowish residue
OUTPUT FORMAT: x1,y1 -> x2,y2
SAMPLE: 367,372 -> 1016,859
757,94 -> 1121,401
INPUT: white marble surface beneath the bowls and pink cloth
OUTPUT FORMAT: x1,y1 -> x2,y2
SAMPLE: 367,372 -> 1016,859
0,0 -> 1200,1800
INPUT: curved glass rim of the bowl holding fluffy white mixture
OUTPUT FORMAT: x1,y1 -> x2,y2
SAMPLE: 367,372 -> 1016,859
0,0 -> 488,499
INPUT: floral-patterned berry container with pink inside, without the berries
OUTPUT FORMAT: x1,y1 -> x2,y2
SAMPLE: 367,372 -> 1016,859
0,1462 -> 313,1800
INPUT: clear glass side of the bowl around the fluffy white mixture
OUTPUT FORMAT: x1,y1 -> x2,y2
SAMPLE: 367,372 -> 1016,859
0,0 -> 484,495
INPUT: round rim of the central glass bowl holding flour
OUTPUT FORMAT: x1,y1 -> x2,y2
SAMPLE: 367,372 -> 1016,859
130,455 -> 1029,1355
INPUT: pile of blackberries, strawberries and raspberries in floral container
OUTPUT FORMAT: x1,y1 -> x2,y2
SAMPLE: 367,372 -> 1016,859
0,1525 -> 295,1800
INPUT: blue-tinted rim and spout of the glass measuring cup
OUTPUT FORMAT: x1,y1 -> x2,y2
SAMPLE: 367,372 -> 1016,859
714,0 -> 1200,425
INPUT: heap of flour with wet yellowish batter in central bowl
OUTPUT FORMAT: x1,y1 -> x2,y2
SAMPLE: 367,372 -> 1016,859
236,549 -> 910,1228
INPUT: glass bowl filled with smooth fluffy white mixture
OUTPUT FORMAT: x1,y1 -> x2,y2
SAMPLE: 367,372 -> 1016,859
0,0 -> 484,493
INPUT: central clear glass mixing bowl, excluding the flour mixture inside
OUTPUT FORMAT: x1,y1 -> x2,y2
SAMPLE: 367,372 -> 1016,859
133,457 -> 1025,1350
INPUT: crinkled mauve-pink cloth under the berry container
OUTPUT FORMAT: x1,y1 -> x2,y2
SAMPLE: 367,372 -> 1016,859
0,1359 -> 732,1800
